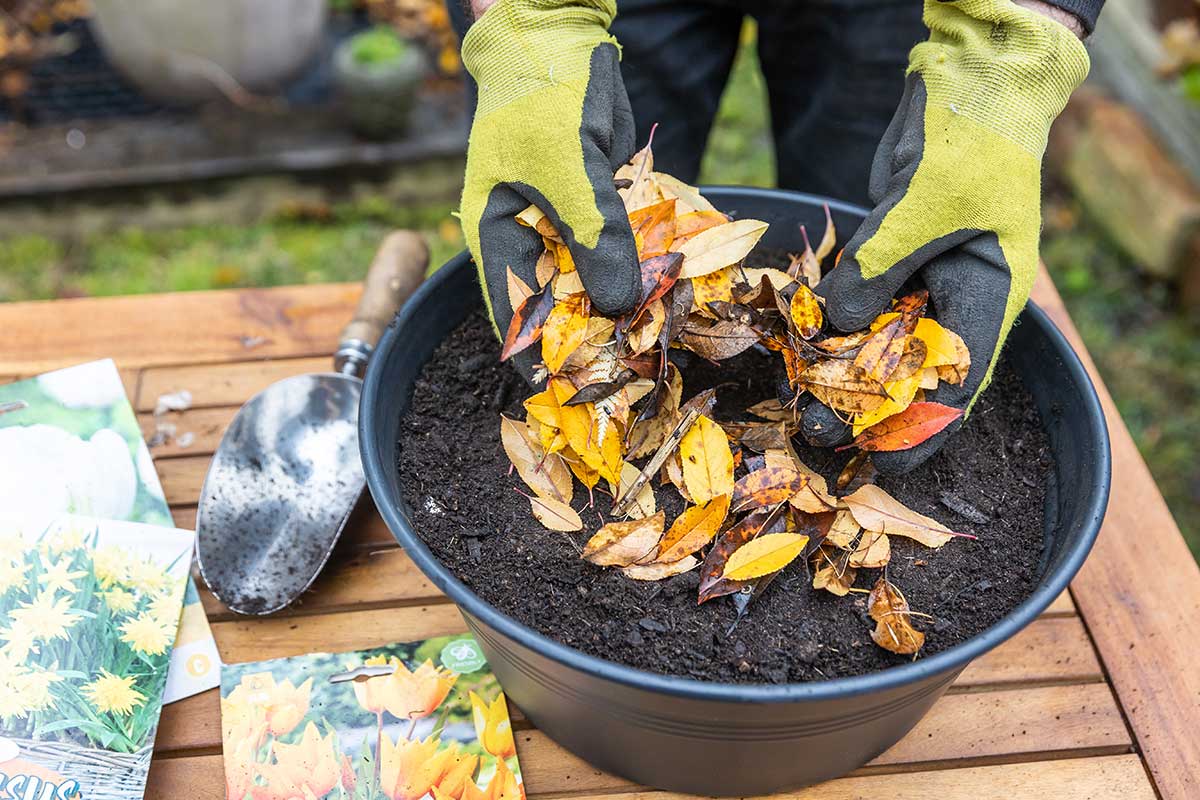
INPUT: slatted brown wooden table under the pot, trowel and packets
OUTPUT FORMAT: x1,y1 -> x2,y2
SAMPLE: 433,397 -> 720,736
0,276 -> 1200,800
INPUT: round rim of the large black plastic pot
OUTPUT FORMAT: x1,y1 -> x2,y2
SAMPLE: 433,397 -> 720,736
359,186 -> 1111,703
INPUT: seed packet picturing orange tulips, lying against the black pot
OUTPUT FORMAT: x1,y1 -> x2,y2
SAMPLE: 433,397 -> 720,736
221,634 -> 524,800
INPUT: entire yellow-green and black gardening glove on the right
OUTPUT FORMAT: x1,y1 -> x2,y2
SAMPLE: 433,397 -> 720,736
802,0 -> 1088,474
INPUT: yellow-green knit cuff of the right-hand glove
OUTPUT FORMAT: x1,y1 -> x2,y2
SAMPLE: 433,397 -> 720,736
908,0 -> 1090,160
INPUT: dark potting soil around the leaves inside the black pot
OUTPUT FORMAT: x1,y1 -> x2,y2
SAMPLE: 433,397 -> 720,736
397,313 -> 1051,682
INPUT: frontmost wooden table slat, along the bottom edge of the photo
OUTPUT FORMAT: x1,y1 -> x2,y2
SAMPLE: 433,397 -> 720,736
145,744 -> 1154,800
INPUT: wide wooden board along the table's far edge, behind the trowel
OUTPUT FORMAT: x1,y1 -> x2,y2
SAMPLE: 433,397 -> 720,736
0,284 -> 360,374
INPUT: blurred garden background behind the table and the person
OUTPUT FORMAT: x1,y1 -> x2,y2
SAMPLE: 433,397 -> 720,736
0,0 -> 1200,553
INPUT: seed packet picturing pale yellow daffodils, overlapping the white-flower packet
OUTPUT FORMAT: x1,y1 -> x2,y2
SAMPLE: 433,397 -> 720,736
0,515 -> 196,800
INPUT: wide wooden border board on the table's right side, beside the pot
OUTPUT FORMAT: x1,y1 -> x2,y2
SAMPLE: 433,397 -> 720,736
1034,270 -> 1200,800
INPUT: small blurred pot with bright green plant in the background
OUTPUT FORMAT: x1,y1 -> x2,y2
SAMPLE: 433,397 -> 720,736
334,25 -> 426,139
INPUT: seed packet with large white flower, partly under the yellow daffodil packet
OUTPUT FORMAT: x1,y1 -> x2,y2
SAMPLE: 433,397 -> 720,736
0,360 -> 221,703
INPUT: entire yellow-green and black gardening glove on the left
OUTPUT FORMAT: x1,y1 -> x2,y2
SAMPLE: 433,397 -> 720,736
462,0 -> 641,378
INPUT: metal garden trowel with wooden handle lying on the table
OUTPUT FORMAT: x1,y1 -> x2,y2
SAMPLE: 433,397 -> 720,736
196,230 -> 430,614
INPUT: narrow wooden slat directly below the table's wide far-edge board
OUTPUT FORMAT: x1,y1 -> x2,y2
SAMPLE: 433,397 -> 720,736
133,355 -> 334,411
